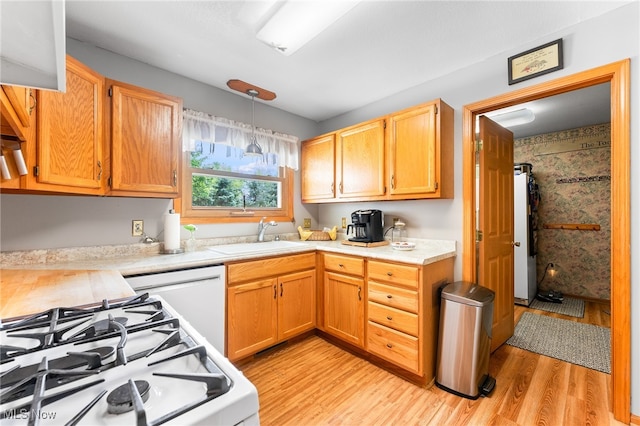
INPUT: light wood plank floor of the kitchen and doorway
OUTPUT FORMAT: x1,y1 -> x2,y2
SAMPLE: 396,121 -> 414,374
240,302 -> 622,426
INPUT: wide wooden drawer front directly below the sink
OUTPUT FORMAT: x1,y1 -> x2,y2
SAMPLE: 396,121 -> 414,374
227,253 -> 316,285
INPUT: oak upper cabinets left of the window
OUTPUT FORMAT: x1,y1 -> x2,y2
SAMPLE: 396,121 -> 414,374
0,56 -> 182,198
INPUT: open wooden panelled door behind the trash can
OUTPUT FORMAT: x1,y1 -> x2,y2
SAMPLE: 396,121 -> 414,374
478,116 -> 514,352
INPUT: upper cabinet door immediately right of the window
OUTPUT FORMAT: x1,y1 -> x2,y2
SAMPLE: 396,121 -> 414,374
300,134 -> 336,203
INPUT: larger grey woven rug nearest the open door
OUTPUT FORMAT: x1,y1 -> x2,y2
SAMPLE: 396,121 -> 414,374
507,312 -> 611,374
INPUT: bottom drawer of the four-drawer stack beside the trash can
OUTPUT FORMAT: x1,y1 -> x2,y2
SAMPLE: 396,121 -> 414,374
367,321 -> 421,374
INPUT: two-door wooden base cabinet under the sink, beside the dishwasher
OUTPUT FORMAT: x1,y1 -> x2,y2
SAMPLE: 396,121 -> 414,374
227,253 -> 316,361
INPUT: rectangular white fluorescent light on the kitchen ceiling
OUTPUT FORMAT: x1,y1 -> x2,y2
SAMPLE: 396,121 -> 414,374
256,0 -> 360,56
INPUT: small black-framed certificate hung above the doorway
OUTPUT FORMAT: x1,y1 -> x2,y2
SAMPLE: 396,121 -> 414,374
507,38 -> 564,85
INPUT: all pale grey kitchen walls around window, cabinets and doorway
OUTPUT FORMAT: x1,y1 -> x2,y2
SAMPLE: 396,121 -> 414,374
0,2 -> 640,415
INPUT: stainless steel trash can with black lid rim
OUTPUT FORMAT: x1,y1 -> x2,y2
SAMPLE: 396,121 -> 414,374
436,281 -> 495,399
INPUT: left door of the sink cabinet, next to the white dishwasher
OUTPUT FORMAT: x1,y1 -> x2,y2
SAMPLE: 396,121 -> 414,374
227,278 -> 278,360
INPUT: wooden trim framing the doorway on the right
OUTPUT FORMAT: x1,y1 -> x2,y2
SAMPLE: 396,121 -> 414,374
462,59 -> 631,424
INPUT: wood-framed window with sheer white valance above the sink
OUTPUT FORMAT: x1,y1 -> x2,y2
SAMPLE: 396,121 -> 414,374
182,110 -> 298,223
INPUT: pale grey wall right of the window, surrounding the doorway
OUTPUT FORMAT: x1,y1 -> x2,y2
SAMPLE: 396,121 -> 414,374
319,2 -> 640,415
